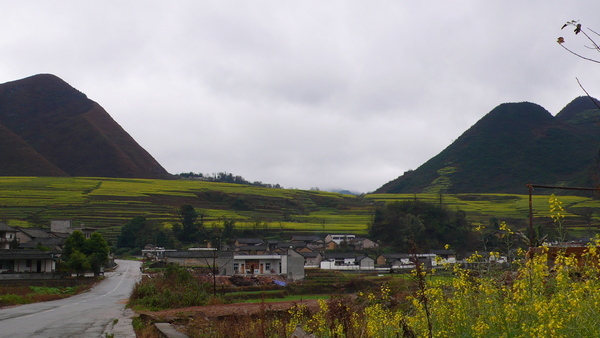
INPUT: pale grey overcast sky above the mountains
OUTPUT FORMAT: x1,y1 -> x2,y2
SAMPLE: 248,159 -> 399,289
0,0 -> 600,192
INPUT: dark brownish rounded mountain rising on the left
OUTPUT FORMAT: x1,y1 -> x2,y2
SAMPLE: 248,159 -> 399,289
0,74 -> 170,178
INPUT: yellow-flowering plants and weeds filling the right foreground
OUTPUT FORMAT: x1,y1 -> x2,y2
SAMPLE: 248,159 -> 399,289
180,242 -> 600,337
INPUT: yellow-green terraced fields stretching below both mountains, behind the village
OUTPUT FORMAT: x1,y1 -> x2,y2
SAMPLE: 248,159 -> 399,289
0,177 -> 600,239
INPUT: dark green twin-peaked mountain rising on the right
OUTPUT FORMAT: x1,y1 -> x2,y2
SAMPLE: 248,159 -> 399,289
375,97 -> 600,193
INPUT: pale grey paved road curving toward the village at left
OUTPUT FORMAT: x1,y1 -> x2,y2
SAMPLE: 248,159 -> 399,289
0,260 -> 140,338
